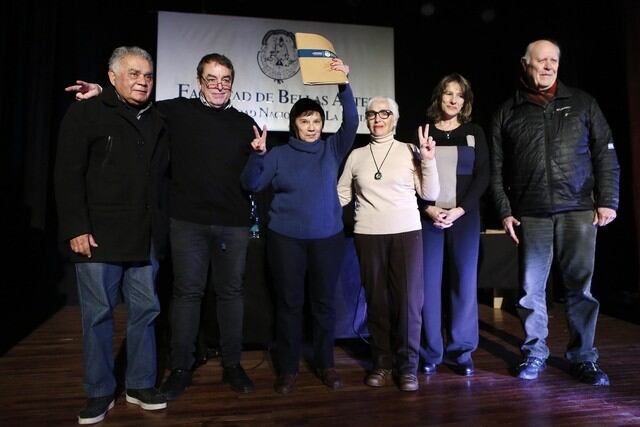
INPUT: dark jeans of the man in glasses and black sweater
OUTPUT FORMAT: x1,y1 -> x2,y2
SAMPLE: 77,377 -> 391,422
170,218 -> 249,369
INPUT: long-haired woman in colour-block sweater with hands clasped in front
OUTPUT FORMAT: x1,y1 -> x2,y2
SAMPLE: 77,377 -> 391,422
421,73 -> 489,376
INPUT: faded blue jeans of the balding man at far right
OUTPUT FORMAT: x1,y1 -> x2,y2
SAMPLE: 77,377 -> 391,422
517,211 -> 600,363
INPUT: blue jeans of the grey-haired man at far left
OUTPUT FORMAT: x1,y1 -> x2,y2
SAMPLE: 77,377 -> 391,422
76,258 -> 160,398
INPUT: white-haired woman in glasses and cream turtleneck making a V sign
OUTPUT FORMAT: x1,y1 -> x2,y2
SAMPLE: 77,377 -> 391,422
338,97 -> 440,391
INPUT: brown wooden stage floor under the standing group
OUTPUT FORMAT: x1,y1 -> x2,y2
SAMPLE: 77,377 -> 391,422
0,305 -> 640,427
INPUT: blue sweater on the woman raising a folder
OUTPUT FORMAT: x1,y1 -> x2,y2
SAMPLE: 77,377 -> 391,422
241,85 -> 358,239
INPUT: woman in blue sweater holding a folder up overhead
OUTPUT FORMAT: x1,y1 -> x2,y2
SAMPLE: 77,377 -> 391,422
241,58 -> 358,393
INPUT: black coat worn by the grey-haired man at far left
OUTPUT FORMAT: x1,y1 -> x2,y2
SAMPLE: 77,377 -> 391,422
55,87 -> 169,262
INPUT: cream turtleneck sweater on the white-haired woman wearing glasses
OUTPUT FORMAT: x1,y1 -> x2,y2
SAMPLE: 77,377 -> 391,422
338,133 -> 440,234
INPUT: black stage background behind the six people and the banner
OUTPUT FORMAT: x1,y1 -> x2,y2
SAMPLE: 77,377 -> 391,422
0,0 -> 640,354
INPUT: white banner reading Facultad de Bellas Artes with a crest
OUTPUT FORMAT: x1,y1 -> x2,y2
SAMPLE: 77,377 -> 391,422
156,12 -> 395,133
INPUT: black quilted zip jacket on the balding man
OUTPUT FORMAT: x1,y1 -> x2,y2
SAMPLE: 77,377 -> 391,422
491,82 -> 620,218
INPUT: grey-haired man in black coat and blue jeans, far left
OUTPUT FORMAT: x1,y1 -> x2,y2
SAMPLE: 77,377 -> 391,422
55,47 -> 169,424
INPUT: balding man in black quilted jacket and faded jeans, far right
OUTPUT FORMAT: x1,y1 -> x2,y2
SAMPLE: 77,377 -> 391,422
491,40 -> 620,385
